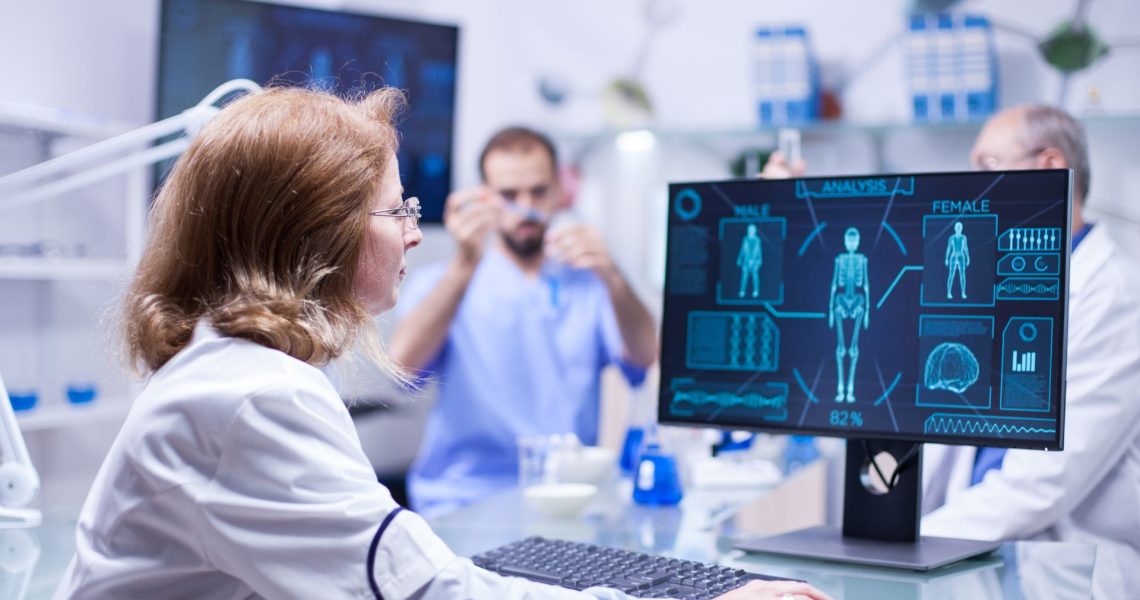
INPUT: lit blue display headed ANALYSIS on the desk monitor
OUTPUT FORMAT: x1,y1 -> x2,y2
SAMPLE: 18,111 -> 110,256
659,170 -> 1072,449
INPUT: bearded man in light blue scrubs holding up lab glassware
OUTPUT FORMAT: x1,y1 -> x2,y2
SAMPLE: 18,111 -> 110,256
389,128 -> 657,516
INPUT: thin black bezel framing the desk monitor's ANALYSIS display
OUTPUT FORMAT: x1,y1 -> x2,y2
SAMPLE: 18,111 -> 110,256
657,169 -> 1073,451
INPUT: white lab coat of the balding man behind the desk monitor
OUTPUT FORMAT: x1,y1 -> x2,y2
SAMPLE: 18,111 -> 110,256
922,222 -> 1140,599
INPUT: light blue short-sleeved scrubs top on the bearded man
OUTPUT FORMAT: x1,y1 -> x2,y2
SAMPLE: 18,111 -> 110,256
398,249 -> 645,516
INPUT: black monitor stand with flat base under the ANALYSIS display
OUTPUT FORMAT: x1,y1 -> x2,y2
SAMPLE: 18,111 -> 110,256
735,439 -> 1001,571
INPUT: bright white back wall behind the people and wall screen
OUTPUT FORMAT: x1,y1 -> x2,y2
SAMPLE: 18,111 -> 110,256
0,0 -> 1140,504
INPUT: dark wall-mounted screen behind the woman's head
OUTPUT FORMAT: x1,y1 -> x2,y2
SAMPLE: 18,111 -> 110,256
157,0 -> 458,221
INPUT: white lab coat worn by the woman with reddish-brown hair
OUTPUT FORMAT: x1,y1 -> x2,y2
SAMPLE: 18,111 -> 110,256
56,324 -> 626,600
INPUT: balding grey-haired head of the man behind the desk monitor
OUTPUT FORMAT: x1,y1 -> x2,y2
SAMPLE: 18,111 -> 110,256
970,105 -> 1090,203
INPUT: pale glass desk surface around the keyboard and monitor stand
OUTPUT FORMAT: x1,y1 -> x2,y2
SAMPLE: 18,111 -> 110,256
8,481 -> 1096,600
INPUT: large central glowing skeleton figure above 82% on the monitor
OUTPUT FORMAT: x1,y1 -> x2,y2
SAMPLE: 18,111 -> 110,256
828,227 -> 871,403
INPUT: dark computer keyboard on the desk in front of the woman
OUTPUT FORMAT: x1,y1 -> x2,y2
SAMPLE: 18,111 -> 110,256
471,536 -> 782,600
